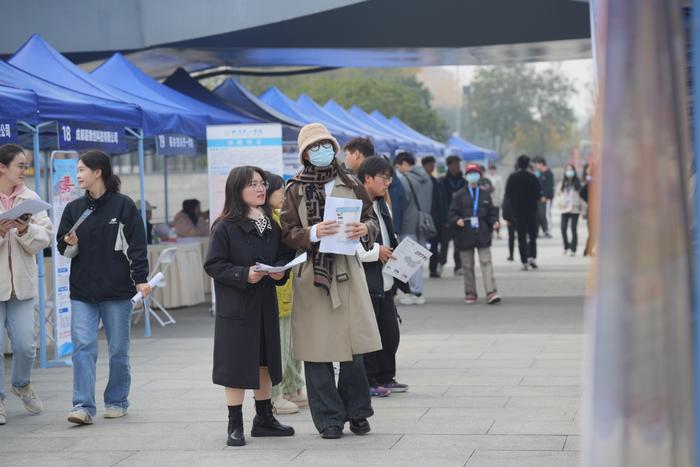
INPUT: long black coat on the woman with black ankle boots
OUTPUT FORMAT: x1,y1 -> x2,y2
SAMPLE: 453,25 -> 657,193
204,219 -> 294,389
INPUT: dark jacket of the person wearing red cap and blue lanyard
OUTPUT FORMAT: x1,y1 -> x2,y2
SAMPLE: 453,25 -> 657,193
449,187 -> 498,250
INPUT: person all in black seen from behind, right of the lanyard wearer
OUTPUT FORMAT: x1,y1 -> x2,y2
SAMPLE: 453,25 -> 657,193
505,155 -> 542,271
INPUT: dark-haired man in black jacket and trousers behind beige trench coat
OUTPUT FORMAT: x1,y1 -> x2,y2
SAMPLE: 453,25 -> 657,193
357,157 -> 409,397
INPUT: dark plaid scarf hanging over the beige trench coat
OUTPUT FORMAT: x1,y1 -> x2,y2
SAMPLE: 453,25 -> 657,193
295,164 -> 337,293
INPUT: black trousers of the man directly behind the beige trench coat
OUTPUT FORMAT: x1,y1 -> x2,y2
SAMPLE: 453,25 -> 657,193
365,292 -> 401,386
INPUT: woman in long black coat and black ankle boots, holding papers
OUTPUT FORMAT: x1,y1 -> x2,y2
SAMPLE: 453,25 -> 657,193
204,166 -> 294,446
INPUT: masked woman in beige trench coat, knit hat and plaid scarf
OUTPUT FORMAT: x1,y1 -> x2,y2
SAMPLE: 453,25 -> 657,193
281,123 -> 381,439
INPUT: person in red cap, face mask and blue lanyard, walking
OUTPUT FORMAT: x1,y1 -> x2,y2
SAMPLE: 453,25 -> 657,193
448,164 -> 501,305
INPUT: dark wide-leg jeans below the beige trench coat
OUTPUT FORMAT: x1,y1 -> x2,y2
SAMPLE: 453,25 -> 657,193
304,355 -> 374,433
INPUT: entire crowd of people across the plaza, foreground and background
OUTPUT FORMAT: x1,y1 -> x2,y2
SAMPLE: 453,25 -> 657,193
0,133 -> 594,446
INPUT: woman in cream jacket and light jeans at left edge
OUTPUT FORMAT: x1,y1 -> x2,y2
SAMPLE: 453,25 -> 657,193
0,144 -> 53,425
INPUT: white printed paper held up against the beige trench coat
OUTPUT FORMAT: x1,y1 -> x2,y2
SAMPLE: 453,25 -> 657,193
319,196 -> 362,256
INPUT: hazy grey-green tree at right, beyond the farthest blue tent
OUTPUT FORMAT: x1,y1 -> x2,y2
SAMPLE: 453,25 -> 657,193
467,65 -> 576,155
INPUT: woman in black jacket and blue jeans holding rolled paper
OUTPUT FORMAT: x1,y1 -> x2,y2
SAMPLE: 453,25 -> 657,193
56,150 -> 151,425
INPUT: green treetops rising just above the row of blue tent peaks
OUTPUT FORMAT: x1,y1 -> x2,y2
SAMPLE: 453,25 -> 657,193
226,69 -> 447,141
